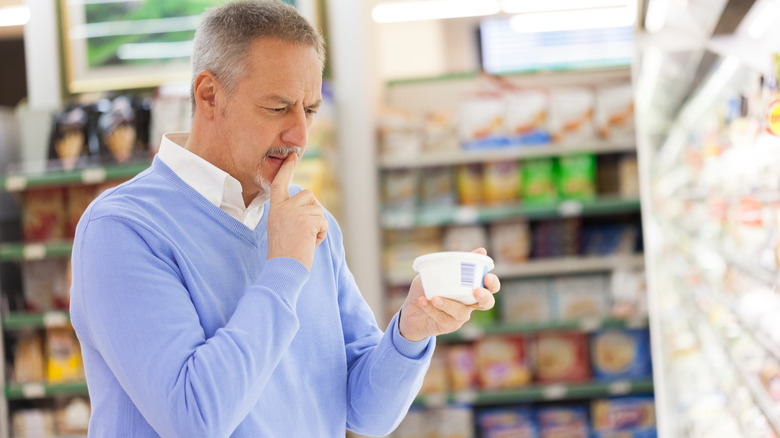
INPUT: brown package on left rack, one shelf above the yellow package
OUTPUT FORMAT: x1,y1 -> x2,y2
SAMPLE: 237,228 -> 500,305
22,258 -> 70,313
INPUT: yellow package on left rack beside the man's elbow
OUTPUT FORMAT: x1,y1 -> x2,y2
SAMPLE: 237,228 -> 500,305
46,327 -> 84,383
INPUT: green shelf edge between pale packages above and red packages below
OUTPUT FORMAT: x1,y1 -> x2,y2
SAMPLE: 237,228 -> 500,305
436,316 -> 647,342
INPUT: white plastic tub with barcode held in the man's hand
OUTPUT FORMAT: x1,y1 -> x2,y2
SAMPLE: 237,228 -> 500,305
412,251 -> 495,304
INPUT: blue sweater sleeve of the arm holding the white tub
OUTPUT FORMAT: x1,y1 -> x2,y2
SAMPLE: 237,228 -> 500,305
328,221 -> 435,436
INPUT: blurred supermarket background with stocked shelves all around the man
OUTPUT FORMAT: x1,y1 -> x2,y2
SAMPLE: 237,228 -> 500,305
0,0 -> 780,438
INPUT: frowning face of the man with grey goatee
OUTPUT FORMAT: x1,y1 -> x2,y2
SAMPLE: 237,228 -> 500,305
217,38 -> 322,199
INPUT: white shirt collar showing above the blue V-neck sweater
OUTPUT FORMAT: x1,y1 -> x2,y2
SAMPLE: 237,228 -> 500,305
157,132 -> 264,230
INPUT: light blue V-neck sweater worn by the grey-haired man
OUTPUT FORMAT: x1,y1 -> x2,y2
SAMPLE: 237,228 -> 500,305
71,159 -> 435,438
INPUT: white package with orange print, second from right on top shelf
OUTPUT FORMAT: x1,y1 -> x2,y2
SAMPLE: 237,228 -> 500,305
548,87 -> 596,143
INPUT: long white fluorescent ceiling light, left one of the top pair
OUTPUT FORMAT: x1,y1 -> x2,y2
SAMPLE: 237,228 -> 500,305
371,0 -> 501,23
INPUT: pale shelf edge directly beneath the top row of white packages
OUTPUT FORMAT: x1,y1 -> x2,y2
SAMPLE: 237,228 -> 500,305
379,141 -> 636,169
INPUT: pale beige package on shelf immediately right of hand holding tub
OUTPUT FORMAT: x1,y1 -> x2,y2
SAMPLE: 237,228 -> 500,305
501,279 -> 553,324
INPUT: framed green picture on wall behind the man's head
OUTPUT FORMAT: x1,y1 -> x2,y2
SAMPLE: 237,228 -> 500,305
60,0 -> 296,93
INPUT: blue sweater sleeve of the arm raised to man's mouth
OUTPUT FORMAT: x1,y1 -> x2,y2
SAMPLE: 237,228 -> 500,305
71,217 -> 309,437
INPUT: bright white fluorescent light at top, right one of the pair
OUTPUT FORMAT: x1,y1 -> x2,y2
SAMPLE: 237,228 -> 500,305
510,6 -> 636,33
